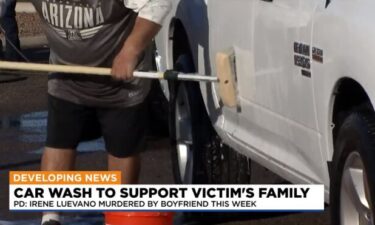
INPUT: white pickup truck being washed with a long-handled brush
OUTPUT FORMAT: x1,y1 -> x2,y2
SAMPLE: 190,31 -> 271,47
156,0 -> 375,225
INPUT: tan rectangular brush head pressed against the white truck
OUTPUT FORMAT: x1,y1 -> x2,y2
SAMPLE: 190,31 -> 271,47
216,51 -> 237,108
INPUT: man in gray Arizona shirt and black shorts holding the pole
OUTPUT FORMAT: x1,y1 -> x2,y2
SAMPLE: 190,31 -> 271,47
22,0 -> 171,225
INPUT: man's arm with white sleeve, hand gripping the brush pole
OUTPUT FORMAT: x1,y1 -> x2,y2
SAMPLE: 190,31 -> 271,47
112,0 -> 171,80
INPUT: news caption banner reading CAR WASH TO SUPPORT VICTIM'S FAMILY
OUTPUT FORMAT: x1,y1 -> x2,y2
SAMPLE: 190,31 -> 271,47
9,171 -> 324,212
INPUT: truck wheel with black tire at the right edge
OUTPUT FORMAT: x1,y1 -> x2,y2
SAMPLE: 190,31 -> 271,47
330,110 -> 375,225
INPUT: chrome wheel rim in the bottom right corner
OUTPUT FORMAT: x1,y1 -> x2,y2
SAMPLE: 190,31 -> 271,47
340,152 -> 374,225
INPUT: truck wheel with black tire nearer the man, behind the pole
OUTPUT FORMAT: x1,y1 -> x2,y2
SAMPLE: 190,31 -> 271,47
170,55 -> 251,184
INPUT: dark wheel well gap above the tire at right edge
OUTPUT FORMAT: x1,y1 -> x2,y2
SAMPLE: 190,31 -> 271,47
332,78 -> 371,140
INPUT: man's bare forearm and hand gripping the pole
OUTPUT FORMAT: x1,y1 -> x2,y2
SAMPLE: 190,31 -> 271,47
112,17 -> 161,80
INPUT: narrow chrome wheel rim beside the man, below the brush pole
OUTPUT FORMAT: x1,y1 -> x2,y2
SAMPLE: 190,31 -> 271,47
175,85 -> 194,184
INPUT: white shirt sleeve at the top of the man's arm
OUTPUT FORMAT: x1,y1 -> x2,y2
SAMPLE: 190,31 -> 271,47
124,0 -> 172,24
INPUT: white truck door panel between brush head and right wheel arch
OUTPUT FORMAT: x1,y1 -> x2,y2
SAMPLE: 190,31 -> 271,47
234,0 -> 325,182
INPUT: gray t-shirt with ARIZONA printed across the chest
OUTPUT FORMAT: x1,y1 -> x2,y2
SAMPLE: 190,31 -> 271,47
31,0 -> 151,107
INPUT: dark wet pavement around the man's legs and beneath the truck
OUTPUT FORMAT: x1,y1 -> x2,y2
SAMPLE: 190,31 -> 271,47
0,48 -> 329,225
